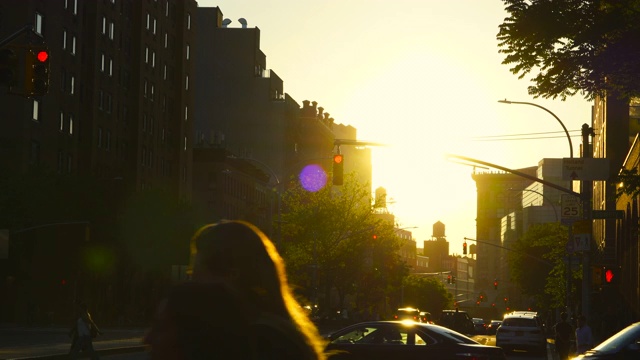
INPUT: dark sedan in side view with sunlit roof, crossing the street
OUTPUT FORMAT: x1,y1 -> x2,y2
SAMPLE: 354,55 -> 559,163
326,321 -> 506,360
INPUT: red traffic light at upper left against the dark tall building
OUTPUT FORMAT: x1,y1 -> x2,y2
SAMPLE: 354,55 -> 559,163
24,46 -> 50,96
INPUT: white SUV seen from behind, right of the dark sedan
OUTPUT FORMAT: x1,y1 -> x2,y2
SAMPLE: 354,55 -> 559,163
496,314 -> 547,355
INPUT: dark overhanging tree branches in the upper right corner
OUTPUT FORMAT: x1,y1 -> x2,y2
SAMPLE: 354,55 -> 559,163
497,0 -> 640,100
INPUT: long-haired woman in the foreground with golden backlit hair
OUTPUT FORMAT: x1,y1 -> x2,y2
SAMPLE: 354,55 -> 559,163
191,221 -> 325,360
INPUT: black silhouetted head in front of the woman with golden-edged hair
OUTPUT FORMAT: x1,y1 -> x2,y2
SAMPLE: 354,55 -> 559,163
144,282 -> 259,360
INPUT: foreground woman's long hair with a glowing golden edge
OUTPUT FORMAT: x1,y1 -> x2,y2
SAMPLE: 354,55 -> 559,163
186,221 -> 325,358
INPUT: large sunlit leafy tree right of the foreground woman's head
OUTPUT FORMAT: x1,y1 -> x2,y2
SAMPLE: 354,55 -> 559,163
281,174 -> 407,314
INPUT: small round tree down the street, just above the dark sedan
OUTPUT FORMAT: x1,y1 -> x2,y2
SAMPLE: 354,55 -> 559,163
401,275 -> 453,314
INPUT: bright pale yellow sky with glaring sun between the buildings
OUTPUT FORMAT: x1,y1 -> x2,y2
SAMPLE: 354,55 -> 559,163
198,0 -> 591,254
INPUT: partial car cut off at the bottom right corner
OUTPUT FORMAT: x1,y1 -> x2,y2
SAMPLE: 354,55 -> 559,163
573,322 -> 640,360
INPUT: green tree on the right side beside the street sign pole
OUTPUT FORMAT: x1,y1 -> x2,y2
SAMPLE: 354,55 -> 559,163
508,223 -> 581,308
